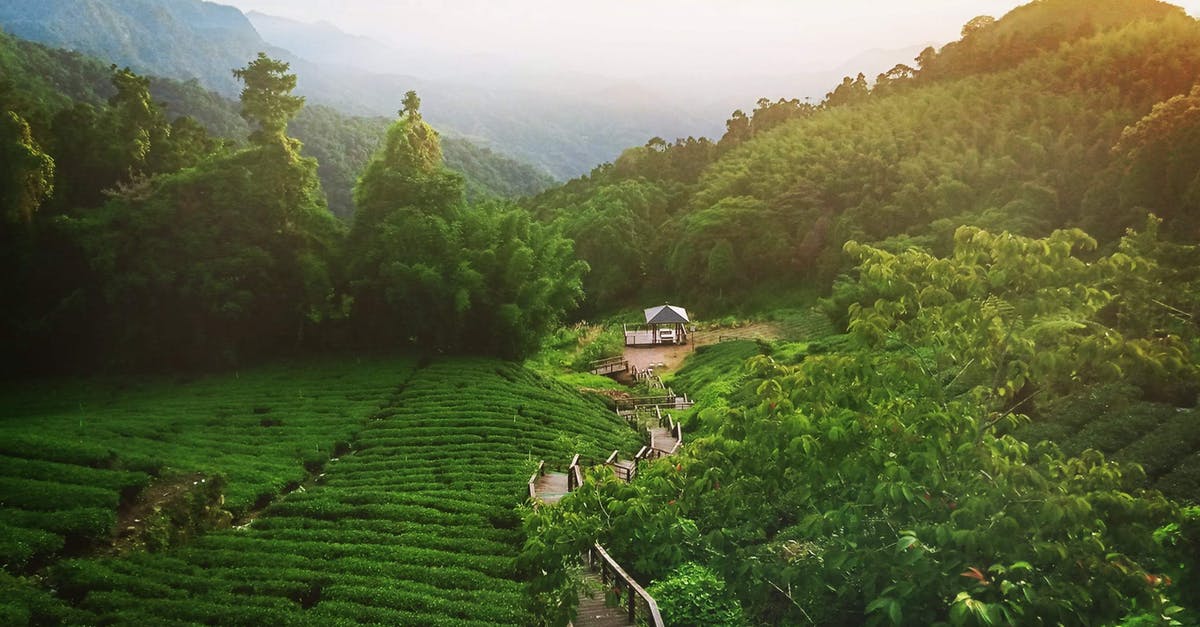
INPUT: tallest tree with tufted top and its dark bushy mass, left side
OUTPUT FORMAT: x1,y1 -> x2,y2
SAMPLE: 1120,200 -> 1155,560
73,56 -> 342,368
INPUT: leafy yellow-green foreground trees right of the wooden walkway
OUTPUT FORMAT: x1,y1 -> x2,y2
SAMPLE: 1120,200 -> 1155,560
527,222 -> 1198,625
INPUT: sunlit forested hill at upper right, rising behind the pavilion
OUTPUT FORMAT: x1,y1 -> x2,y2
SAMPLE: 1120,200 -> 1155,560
532,1 -> 1200,307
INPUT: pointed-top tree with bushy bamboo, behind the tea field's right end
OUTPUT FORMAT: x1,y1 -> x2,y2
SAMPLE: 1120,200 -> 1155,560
348,92 -> 587,358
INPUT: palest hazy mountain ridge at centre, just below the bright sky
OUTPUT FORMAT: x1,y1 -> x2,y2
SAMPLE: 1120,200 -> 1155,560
240,11 -> 710,179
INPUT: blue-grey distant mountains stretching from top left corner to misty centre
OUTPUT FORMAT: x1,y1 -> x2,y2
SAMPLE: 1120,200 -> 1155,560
0,0 -> 709,179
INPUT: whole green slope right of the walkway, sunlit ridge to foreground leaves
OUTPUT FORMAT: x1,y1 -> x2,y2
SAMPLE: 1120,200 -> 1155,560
527,0 -> 1200,625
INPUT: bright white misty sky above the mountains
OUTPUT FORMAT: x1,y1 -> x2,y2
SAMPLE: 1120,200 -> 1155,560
218,0 -> 1200,78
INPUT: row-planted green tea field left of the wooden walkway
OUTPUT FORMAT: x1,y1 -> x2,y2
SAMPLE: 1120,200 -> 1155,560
0,359 -> 637,625
